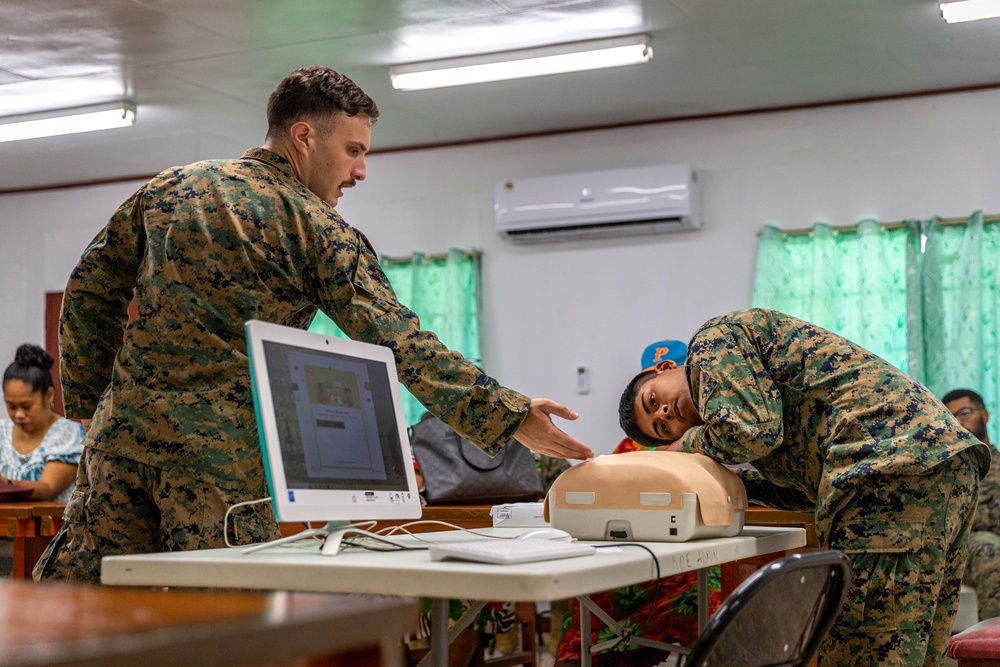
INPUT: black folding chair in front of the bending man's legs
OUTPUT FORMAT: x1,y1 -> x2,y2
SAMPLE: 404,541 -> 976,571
683,551 -> 851,667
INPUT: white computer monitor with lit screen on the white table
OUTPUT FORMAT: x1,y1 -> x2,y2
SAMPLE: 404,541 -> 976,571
246,320 -> 421,554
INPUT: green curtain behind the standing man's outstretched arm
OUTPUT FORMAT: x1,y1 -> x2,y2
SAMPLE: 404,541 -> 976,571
309,249 -> 481,425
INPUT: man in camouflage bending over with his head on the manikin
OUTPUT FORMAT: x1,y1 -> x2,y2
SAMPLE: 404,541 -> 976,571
619,309 -> 990,667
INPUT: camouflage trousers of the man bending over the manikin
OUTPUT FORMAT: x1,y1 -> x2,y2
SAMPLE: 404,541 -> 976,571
819,452 -> 979,667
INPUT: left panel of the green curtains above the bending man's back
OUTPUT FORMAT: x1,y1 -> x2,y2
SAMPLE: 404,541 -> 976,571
753,220 -> 907,372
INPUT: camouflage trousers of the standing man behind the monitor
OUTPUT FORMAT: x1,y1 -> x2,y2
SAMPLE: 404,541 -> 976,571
32,447 -> 280,583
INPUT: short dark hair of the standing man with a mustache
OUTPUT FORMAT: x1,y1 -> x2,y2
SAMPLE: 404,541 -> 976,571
267,65 -> 379,137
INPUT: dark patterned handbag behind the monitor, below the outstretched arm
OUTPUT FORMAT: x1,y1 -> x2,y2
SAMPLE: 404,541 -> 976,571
410,414 -> 542,505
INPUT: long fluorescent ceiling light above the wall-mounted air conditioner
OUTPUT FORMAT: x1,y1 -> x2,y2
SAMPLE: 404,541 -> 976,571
389,35 -> 653,90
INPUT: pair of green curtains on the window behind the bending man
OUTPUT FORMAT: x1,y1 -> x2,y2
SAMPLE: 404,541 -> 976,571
753,211 -> 1000,442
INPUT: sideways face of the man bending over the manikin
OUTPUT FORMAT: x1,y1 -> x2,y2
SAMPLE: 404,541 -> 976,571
634,360 -> 705,441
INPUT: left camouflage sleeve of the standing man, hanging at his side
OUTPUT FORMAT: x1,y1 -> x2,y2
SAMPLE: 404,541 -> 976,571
59,189 -> 145,419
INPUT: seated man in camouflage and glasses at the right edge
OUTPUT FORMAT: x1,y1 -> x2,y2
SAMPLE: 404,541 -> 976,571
941,389 -> 1000,620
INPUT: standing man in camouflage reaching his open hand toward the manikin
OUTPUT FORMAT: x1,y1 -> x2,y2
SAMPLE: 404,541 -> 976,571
34,67 -> 593,582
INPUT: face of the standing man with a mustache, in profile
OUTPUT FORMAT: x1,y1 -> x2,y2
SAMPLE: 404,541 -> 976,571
298,114 -> 372,206
